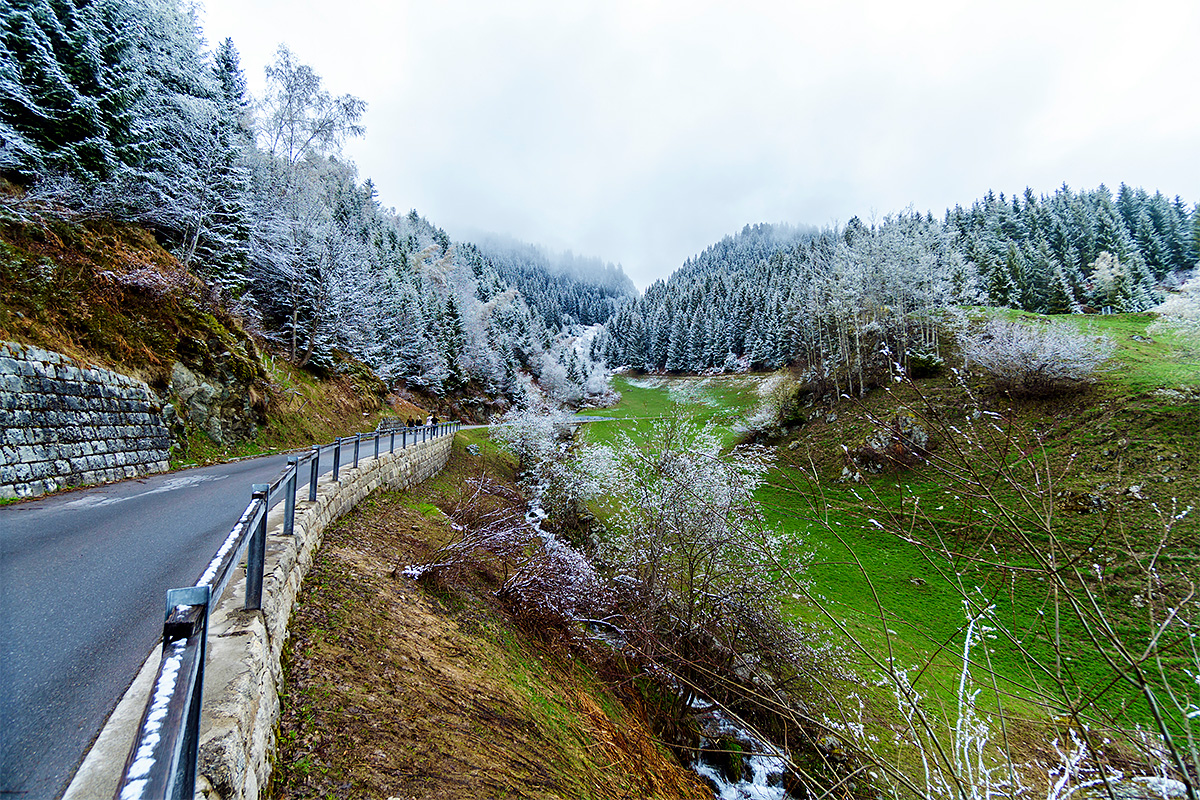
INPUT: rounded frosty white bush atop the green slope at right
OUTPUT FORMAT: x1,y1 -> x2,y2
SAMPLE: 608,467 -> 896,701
962,320 -> 1116,397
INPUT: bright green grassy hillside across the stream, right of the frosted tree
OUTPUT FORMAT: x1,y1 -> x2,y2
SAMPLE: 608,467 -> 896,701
586,314 -> 1200,789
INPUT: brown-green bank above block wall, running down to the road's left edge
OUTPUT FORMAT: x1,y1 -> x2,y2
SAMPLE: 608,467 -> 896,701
0,207 -> 424,468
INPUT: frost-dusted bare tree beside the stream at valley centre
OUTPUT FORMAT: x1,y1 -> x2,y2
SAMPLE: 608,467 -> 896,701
581,414 -> 796,670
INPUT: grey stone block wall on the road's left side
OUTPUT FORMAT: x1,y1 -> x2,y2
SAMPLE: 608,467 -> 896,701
0,342 -> 170,499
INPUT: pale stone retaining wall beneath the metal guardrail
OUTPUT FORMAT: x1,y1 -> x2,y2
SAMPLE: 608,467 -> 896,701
64,435 -> 454,800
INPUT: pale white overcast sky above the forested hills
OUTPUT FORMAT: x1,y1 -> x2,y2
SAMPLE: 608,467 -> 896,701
203,0 -> 1200,289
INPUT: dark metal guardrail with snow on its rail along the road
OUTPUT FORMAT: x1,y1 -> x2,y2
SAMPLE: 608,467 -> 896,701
114,422 -> 458,800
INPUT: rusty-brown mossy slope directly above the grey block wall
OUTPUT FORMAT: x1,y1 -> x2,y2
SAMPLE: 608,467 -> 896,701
0,209 -> 265,386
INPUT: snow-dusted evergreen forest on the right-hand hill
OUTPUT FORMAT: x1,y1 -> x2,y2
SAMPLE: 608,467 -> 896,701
609,185 -> 1200,391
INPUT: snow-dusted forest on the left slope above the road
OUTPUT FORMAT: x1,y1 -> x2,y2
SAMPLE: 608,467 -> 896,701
0,0 -> 624,396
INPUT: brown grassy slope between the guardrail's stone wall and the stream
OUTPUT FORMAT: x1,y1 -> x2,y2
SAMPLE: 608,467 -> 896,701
270,429 -> 712,800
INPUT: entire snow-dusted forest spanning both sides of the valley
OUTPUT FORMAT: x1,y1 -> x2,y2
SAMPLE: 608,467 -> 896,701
0,0 -> 1200,403
